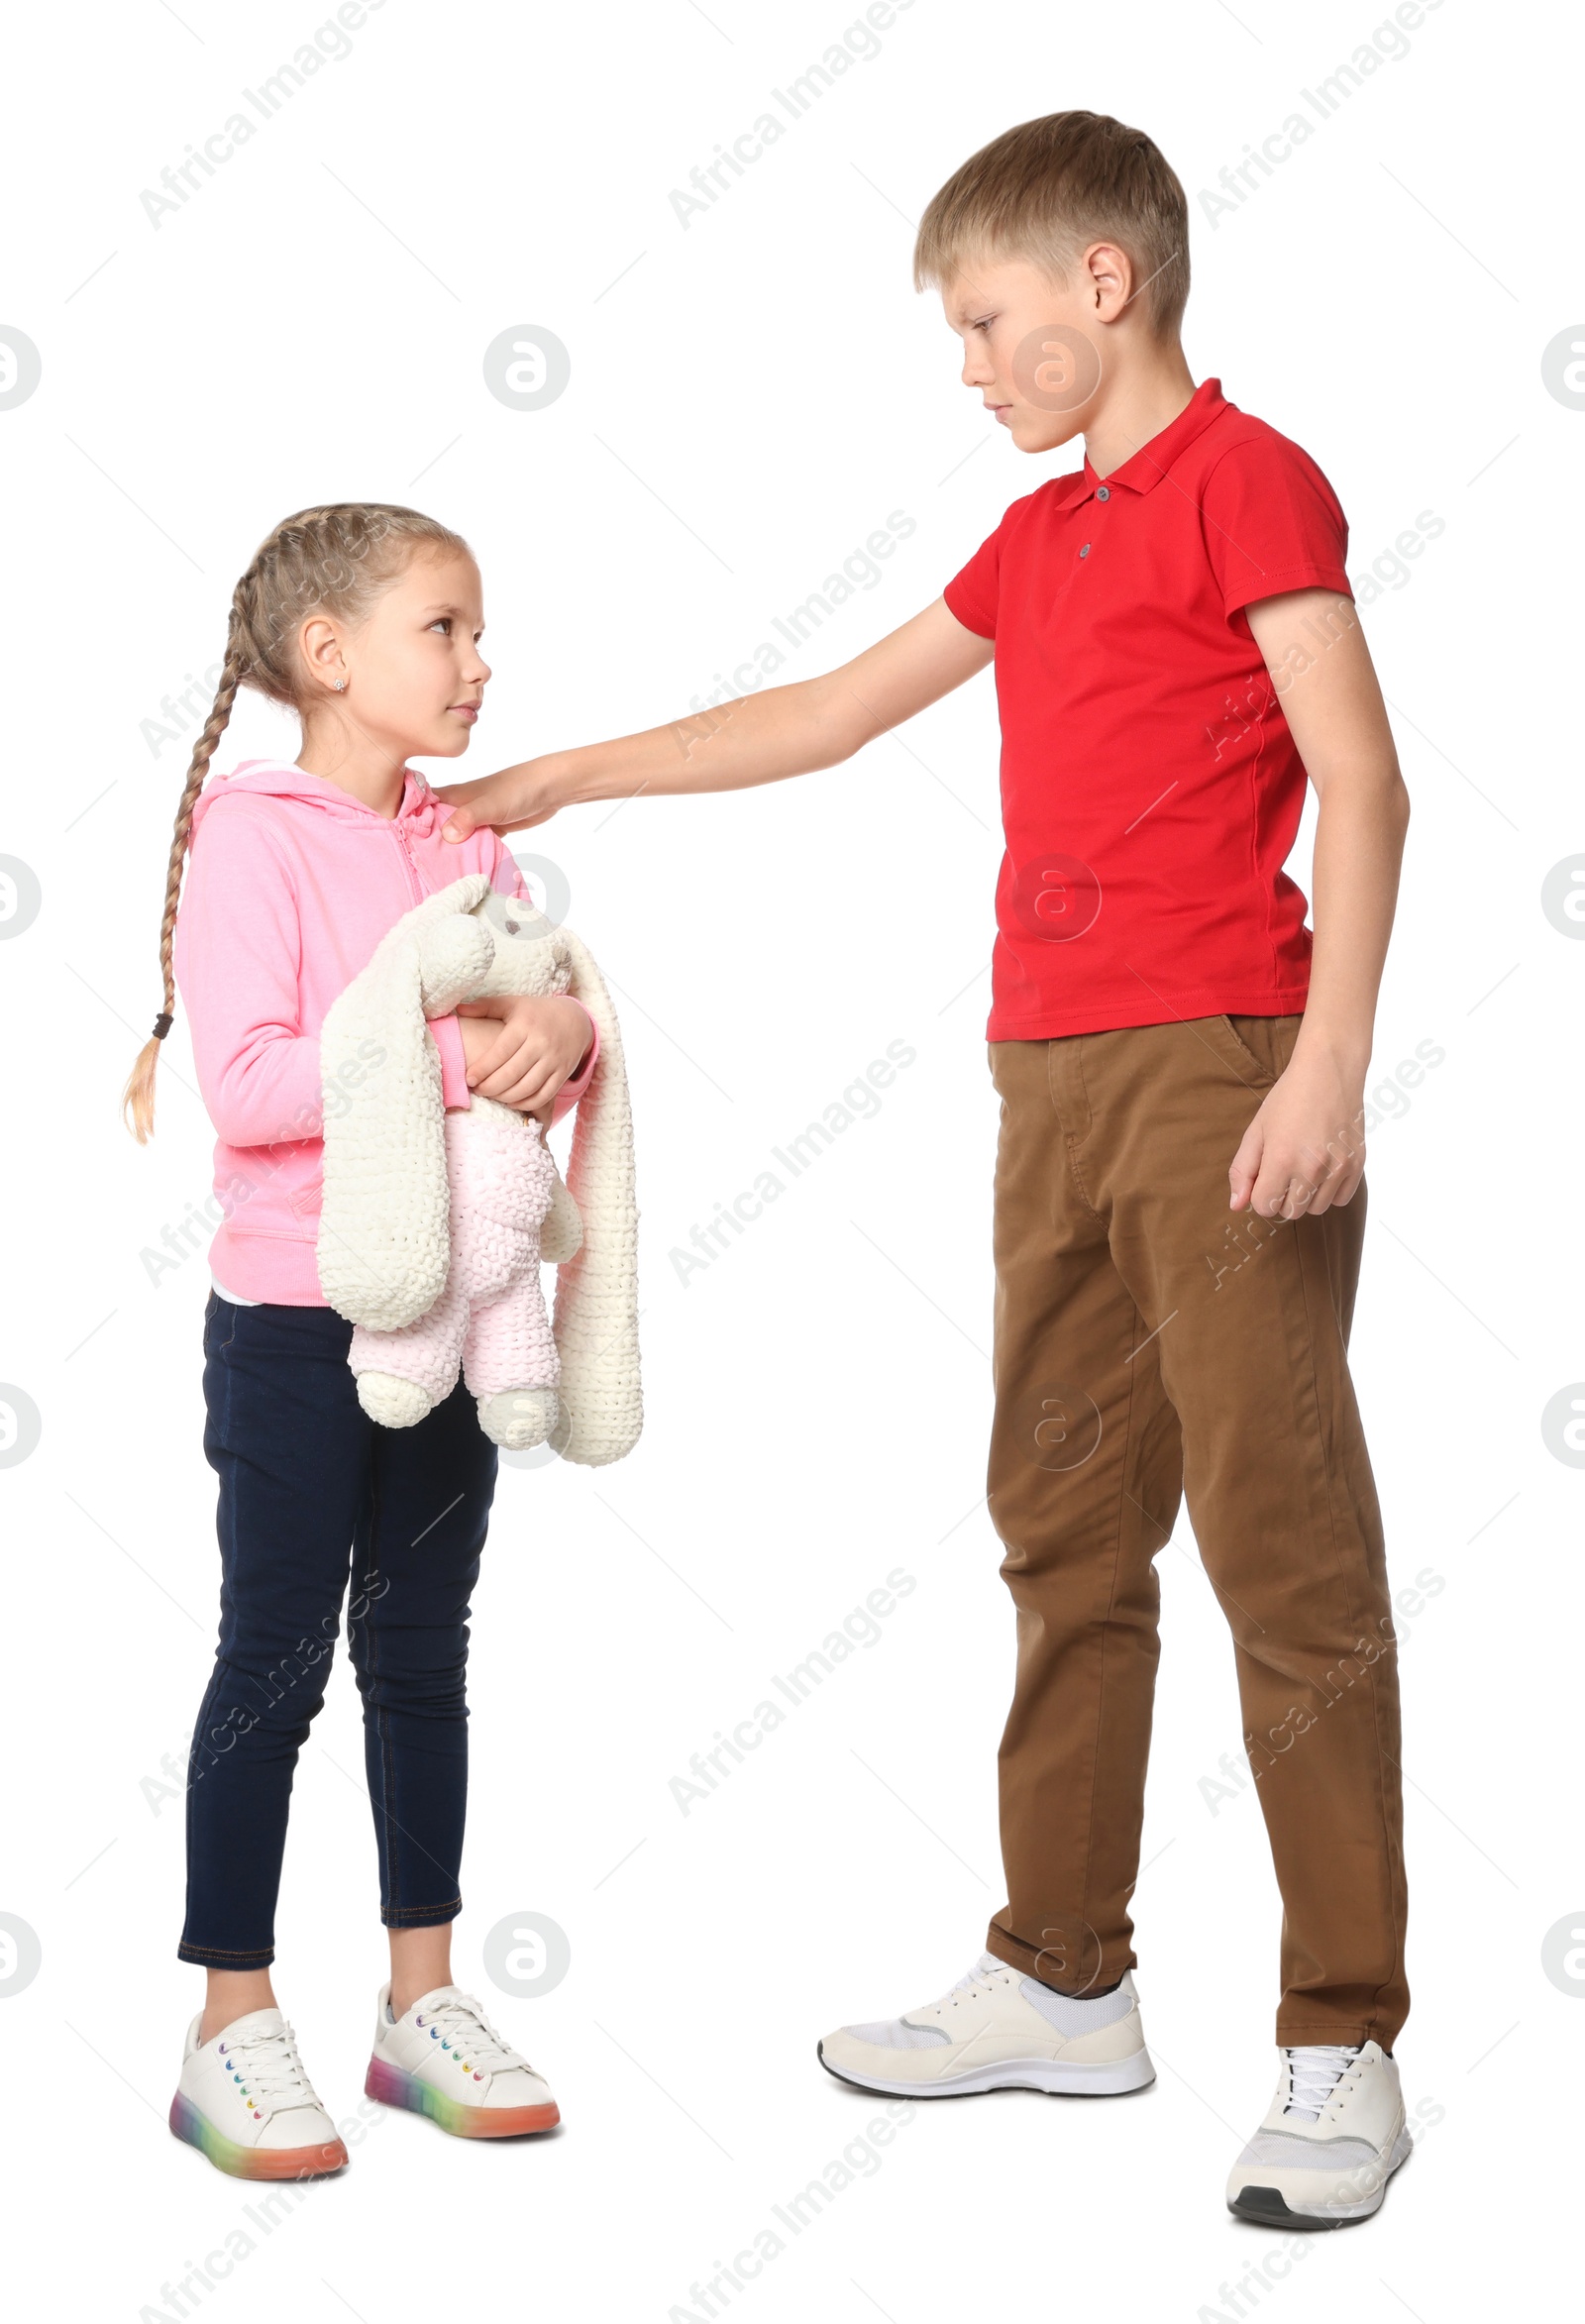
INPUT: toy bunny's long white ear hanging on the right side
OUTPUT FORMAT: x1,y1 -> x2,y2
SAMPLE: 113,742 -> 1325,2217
553,927 -> 644,1469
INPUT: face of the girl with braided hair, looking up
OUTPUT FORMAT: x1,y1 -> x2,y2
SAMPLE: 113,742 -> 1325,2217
302,551 -> 490,762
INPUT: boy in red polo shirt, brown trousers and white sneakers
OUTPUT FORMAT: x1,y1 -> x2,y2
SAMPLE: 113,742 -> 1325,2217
446,112 -> 1409,2226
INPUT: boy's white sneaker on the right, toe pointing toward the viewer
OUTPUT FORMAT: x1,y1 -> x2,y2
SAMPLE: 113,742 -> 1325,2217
1227,2041 -> 1413,2229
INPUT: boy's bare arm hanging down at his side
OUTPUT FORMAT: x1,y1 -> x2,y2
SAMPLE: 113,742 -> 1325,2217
1229,588 -> 1409,1217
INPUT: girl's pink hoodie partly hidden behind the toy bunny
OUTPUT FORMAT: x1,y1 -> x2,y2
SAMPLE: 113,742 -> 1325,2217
176,758 -> 597,1306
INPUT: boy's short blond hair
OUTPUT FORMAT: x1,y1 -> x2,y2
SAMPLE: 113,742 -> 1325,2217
913,112 -> 1190,340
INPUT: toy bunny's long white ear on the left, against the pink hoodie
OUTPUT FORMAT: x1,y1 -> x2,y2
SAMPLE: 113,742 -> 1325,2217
318,872 -> 490,1331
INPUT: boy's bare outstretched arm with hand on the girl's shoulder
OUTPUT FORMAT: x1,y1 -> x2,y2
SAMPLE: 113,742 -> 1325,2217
439,597 -> 995,839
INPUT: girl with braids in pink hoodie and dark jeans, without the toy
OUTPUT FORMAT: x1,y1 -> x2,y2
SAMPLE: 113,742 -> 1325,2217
126,504 -> 597,2177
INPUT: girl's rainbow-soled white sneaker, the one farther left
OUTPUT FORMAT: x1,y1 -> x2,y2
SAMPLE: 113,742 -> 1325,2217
169,2010 -> 347,2180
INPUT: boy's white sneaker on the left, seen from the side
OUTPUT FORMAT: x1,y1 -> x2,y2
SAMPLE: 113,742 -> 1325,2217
818,1953 -> 1155,2098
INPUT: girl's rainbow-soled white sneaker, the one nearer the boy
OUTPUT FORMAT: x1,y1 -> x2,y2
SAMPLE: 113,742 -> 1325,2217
363,1984 -> 563,2138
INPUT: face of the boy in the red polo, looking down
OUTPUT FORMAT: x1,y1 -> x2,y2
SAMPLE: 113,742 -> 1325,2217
941,249 -> 1106,451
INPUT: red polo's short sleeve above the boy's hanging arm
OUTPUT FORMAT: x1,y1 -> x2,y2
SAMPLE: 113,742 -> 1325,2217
1200,430 -> 1352,613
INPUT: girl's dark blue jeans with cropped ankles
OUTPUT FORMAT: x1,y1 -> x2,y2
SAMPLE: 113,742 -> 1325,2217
176,1295 -> 495,1968
